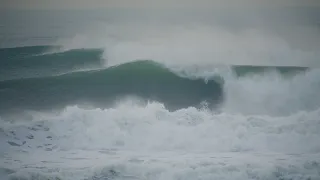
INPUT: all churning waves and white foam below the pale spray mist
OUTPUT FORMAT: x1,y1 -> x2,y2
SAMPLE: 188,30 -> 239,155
0,46 -> 320,180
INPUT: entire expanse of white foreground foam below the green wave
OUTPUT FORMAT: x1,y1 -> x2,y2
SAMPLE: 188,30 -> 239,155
0,101 -> 320,179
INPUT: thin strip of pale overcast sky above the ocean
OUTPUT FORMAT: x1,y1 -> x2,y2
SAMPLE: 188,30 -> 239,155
0,0 -> 320,9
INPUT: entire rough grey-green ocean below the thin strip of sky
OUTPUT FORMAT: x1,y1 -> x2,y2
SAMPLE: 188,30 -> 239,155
0,8 -> 320,180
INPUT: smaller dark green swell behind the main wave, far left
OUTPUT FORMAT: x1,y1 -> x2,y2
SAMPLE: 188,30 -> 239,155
0,46 -> 103,81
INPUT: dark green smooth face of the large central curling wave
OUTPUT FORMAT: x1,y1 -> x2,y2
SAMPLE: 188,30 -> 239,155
0,61 -> 222,111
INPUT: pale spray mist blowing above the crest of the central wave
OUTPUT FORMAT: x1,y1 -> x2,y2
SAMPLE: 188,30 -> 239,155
58,14 -> 319,66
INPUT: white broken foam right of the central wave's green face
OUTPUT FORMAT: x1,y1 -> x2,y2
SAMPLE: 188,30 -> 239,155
224,69 -> 320,116
